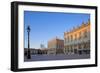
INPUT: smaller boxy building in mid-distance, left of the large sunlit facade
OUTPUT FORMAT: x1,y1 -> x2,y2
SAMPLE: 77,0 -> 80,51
48,37 -> 64,54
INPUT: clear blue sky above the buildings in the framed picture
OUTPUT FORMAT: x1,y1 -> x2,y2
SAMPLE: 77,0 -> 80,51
24,11 -> 90,48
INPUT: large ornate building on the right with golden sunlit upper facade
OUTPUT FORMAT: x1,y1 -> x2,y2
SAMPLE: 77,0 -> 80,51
64,20 -> 90,54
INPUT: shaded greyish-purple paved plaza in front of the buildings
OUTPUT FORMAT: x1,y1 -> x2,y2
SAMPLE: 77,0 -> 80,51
24,54 -> 90,62
